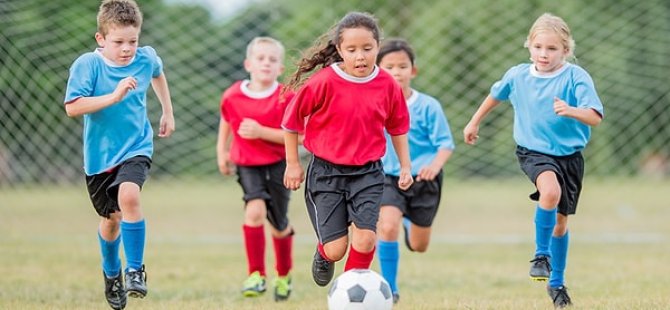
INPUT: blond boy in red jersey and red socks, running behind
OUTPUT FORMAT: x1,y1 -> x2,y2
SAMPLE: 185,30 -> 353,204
216,37 -> 293,301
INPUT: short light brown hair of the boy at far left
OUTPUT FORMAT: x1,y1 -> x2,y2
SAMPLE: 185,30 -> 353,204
97,0 -> 142,36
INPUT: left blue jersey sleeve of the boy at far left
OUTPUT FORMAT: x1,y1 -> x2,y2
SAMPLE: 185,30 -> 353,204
64,53 -> 95,104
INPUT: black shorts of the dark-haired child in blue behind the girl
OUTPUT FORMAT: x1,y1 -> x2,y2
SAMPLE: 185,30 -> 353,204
382,171 -> 442,227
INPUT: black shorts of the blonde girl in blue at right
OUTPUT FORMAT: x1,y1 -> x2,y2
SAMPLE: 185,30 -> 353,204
516,146 -> 584,215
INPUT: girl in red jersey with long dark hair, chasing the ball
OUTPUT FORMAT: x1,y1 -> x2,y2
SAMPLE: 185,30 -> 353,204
282,12 -> 413,286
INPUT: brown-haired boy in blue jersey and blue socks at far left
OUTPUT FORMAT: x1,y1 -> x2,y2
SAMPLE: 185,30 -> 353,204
65,0 -> 175,309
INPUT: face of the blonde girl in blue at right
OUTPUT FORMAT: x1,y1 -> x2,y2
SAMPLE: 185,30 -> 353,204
528,31 -> 569,73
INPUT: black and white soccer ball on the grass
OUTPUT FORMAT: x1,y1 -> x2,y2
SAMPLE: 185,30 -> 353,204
328,269 -> 393,310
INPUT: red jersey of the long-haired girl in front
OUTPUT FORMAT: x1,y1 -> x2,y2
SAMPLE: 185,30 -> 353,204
282,64 -> 409,166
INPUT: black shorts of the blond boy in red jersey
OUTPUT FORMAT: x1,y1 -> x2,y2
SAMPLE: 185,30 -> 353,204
237,160 -> 291,231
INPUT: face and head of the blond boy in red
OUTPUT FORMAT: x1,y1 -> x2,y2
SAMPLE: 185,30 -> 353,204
244,42 -> 284,84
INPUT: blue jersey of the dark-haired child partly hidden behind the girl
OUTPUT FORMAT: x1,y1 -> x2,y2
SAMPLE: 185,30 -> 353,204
382,90 -> 454,176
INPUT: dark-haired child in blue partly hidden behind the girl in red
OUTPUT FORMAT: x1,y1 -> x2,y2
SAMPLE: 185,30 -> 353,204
377,39 -> 454,303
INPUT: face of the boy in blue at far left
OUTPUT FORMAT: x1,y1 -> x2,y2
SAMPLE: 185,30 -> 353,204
95,25 -> 140,66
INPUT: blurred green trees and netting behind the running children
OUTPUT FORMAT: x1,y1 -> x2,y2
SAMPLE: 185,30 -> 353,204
0,0 -> 670,187
